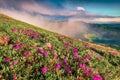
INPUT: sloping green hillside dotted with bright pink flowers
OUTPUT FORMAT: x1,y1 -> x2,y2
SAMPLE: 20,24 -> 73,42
0,14 -> 120,80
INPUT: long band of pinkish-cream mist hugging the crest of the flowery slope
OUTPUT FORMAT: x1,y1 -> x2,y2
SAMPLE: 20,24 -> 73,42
0,5 -> 89,37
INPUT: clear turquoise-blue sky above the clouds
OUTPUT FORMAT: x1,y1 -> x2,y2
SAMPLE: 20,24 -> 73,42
37,0 -> 120,16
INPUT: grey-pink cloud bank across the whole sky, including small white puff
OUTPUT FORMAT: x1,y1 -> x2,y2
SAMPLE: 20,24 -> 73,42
0,0 -> 120,23
